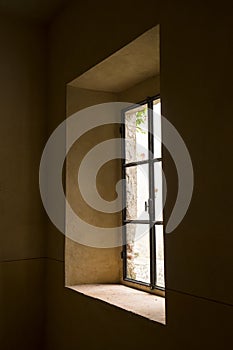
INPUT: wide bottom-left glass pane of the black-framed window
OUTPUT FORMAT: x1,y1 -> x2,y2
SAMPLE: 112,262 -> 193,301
126,224 -> 150,283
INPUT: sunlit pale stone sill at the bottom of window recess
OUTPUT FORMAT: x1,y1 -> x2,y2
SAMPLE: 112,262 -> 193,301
68,284 -> 166,325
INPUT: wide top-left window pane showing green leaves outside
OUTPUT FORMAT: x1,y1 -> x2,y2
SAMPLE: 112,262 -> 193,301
125,105 -> 148,163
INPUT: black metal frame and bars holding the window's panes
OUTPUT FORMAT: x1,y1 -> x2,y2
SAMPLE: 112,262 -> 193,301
120,94 -> 165,291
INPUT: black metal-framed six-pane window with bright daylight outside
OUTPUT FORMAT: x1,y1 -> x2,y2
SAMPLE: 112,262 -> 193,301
122,96 -> 165,290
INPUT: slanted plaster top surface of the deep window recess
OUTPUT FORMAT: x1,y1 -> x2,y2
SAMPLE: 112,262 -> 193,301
69,26 -> 160,93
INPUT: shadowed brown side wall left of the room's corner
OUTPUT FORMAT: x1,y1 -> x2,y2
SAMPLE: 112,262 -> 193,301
0,15 -> 46,350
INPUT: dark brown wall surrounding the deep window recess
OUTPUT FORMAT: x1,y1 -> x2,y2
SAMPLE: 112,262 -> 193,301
47,0 -> 233,350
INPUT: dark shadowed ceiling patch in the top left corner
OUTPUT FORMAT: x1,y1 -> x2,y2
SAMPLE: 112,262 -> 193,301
0,0 -> 71,22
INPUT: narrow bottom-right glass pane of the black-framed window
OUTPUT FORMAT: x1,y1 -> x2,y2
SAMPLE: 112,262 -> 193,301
155,225 -> 165,288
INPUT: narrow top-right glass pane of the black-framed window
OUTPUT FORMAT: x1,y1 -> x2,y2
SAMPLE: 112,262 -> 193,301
153,99 -> 162,158
